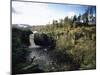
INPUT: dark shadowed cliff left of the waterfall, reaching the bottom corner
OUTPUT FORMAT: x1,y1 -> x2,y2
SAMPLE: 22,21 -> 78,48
12,27 -> 32,73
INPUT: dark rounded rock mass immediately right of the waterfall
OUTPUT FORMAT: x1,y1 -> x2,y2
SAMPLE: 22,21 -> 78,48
34,33 -> 56,48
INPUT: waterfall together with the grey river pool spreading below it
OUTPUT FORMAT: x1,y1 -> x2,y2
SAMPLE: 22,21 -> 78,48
27,34 -> 53,69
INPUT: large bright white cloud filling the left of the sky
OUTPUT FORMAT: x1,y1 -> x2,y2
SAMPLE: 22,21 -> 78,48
12,2 -> 67,25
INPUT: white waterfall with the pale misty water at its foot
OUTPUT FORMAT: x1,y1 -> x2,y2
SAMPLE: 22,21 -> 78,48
28,32 -> 51,66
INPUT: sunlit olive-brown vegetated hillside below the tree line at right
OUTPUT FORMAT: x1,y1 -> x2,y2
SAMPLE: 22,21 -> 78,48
33,23 -> 96,70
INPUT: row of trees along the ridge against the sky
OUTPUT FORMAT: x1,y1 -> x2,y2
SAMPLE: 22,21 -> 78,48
49,6 -> 96,27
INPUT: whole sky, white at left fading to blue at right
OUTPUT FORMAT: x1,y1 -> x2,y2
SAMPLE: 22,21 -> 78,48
12,1 -> 95,25
